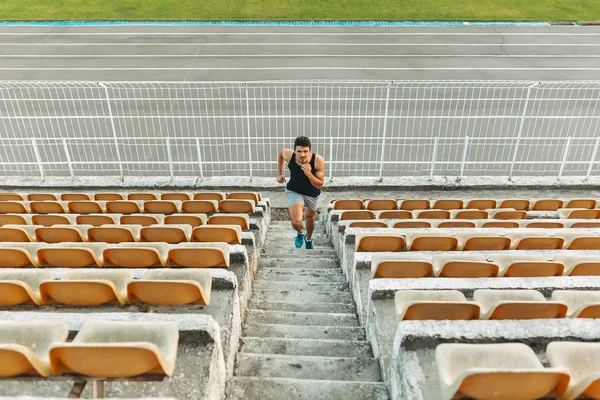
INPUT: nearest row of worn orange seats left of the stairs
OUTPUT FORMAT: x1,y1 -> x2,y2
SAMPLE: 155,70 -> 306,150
0,321 -> 179,378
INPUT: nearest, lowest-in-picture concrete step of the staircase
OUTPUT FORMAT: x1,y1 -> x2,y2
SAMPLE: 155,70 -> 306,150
227,377 -> 389,400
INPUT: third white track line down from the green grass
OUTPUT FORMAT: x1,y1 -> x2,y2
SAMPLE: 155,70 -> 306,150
0,54 -> 600,58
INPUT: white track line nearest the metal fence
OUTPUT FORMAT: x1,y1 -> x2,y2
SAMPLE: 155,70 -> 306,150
0,67 -> 600,71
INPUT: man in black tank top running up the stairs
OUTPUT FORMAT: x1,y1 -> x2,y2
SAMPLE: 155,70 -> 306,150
277,136 -> 325,249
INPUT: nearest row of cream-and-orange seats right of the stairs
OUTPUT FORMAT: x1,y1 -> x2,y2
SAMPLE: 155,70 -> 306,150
435,342 -> 600,400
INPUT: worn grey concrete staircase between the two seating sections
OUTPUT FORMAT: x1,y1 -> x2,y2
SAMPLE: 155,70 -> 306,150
227,221 -> 389,400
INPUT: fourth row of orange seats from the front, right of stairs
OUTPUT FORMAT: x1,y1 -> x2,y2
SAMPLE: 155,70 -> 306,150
355,229 -> 600,252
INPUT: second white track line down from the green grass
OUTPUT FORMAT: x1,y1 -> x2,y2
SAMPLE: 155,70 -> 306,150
0,42 -> 600,47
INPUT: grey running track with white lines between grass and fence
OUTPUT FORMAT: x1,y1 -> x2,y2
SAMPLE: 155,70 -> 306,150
0,26 -> 600,81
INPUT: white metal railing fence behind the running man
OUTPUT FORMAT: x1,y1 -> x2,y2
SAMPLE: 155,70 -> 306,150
0,81 -> 600,179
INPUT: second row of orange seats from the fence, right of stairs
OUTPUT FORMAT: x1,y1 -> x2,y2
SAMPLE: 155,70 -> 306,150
339,208 -> 600,221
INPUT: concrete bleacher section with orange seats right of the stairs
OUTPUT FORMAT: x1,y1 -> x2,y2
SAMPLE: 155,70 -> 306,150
326,198 -> 600,400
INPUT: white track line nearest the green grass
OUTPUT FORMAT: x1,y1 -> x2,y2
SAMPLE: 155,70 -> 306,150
0,32 -> 600,36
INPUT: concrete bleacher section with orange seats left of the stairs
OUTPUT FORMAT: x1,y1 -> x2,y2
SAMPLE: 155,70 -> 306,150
0,192 -> 270,399
